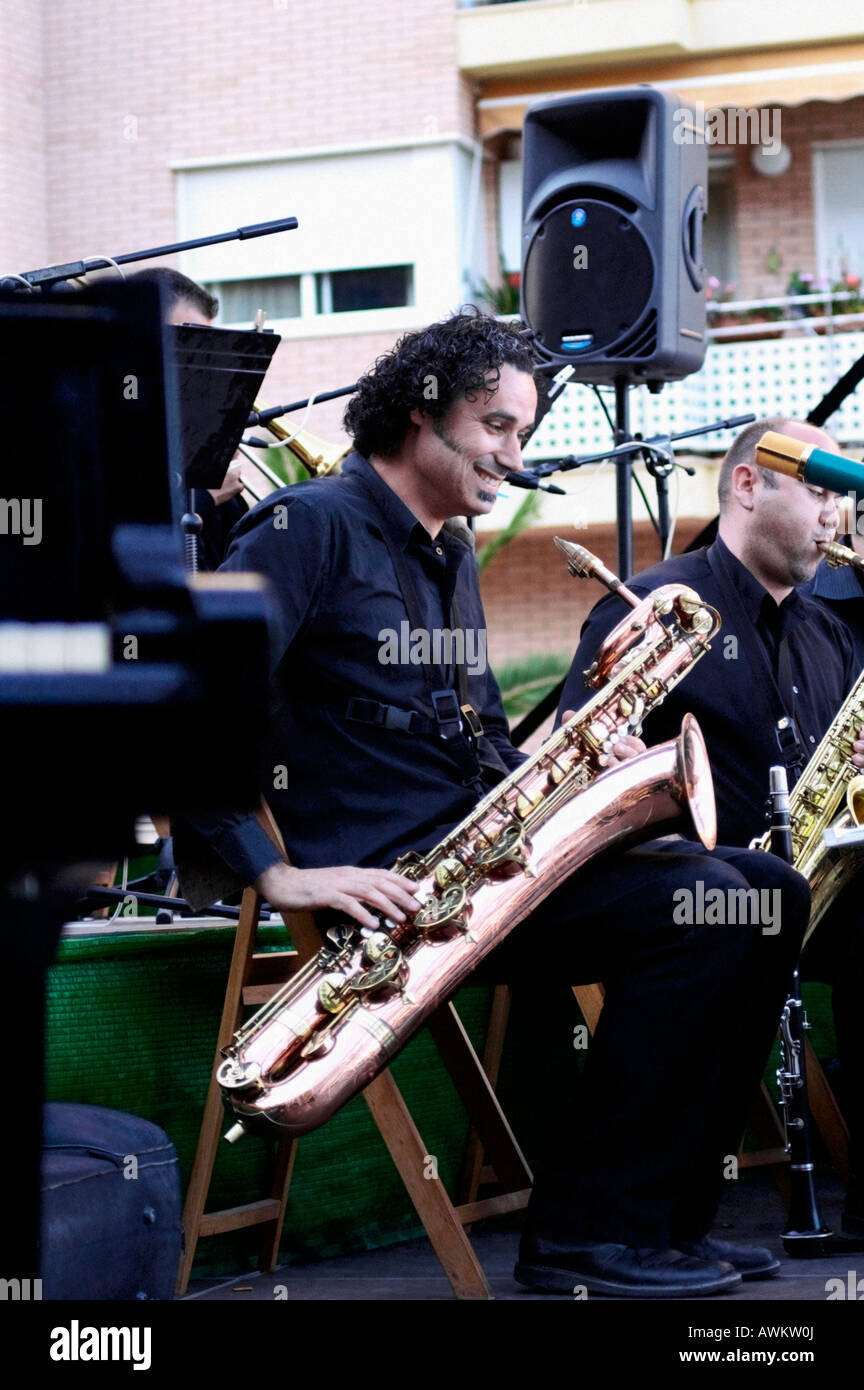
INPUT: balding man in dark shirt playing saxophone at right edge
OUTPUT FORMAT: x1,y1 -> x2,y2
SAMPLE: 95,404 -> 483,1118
561,418 -> 864,1234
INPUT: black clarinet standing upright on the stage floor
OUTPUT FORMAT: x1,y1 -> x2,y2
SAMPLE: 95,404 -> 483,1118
770,767 -> 832,1259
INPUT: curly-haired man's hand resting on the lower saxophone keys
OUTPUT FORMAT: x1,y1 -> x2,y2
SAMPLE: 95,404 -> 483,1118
256,863 -> 419,927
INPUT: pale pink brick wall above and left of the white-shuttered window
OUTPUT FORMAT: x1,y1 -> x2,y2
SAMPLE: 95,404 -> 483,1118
37,0 -> 474,259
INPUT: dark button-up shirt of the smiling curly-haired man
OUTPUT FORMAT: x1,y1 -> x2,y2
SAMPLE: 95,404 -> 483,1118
187,453 -> 524,881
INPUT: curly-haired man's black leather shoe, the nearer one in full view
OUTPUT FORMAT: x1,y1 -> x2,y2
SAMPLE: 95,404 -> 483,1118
514,1240 -> 740,1298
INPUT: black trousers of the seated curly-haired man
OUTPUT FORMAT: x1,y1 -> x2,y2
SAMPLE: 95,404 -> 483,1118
475,841 -> 810,1248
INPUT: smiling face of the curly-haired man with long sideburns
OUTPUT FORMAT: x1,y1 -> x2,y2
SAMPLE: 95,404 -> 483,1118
411,363 -> 538,518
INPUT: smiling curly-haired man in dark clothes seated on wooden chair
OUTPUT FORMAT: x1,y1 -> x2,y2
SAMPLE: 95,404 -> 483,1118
191,313 -> 808,1297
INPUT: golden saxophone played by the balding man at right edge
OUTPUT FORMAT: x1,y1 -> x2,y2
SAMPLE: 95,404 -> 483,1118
750,541 -> 864,945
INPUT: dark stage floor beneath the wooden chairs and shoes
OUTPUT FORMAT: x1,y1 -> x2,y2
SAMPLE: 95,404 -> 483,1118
185,1172 -> 864,1304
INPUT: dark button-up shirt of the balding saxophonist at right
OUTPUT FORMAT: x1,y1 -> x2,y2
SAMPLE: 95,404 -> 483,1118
560,538 -> 857,845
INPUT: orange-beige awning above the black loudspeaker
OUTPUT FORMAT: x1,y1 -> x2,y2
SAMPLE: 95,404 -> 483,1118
478,43 -> 864,136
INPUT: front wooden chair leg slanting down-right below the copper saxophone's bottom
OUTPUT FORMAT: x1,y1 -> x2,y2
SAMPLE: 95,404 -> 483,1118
363,1072 -> 492,1300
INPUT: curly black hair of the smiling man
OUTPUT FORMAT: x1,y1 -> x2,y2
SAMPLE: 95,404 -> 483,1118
343,304 -> 536,459
